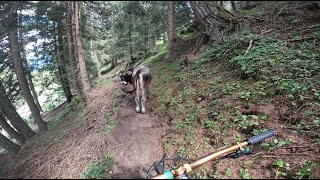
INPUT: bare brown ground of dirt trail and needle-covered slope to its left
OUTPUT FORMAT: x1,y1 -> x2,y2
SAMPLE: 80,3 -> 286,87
1,62 -> 166,179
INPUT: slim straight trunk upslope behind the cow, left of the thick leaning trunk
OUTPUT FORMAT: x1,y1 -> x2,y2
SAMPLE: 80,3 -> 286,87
168,1 -> 176,56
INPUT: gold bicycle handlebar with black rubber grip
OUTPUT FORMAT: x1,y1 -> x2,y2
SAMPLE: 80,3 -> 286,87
150,130 -> 276,179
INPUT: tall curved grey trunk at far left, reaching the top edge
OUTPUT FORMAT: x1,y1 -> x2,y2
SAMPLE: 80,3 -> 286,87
9,1 -> 47,131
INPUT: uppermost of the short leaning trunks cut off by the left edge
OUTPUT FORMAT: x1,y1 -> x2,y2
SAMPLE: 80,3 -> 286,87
0,81 -> 35,140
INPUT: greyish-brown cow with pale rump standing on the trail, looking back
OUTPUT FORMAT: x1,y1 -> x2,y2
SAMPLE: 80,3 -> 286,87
120,66 -> 151,113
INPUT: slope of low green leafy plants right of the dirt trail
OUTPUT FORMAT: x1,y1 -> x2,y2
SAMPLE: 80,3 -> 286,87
146,22 -> 320,179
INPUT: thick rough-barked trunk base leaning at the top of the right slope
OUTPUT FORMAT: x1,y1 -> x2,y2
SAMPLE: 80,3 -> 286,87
189,1 -> 237,42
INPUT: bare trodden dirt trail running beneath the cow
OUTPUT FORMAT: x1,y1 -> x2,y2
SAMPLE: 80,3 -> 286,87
107,63 -> 166,179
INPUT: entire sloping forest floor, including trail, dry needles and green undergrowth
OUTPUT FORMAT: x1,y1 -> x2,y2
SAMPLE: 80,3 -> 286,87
0,3 -> 320,179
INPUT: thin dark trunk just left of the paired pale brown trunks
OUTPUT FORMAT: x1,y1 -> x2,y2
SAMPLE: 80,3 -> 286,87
58,22 -> 73,103
